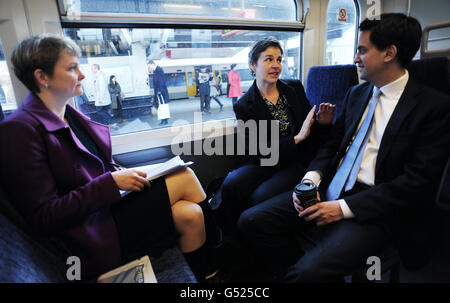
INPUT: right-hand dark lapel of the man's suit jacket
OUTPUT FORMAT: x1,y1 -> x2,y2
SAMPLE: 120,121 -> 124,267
375,78 -> 420,176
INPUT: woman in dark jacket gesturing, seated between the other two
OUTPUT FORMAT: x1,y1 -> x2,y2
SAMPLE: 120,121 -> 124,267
219,38 -> 335,233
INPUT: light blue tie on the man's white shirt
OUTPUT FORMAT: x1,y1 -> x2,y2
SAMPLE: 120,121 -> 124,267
327,88 -> 381,201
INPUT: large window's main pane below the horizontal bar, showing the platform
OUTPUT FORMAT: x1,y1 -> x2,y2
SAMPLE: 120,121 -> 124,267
64,28 -> 301,135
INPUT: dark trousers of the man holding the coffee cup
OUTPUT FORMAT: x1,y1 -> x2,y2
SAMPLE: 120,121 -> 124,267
238,191 -> 390,282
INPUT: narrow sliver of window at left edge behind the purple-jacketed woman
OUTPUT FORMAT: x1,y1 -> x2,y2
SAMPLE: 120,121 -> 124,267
0,37 -> 17,119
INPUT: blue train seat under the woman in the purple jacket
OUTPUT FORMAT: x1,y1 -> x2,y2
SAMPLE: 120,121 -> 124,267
0,188 -> 196,283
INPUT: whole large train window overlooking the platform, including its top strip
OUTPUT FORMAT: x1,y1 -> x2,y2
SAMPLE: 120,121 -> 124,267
61,0 -> 304,154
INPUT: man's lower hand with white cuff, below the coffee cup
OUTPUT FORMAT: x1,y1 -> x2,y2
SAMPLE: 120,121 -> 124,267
297,200 -> 344,226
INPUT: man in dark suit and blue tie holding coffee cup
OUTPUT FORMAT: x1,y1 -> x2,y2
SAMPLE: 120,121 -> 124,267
238,14 -> 450,282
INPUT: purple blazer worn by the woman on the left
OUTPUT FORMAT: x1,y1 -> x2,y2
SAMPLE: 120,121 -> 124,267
0,93 -> 121,276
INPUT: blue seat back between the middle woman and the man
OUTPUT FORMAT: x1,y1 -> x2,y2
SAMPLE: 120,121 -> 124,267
306,64 -> 359,120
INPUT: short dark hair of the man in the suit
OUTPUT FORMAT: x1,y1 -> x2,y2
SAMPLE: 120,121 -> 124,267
359,13 -> 422,67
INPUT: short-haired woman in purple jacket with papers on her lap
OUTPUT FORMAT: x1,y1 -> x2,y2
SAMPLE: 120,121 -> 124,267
0,35 -> 211,280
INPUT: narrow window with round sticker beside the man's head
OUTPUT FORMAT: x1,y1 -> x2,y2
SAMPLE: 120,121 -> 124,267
325,0 -> 359,65
